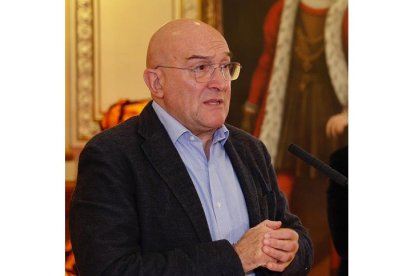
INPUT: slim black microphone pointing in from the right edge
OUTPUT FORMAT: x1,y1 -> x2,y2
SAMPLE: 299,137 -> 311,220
288,144 -> 348,187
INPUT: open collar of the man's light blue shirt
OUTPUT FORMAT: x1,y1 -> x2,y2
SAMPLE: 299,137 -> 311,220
152,101 -> 229,145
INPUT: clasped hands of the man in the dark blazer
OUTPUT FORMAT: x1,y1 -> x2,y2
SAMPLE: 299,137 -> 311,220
234,220 -> 299,272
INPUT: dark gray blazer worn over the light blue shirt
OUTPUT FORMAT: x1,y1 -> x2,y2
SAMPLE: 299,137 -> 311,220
70,103 -> 313,276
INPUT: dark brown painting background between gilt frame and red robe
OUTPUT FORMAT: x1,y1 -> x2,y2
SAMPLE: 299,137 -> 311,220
222,0 -> 275,126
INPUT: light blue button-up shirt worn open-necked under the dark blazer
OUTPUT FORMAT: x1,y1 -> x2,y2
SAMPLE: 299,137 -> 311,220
153,102 -> 249,244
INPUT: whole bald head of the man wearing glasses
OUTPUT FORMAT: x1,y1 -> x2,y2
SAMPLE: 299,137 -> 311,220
143,19 -> 231,139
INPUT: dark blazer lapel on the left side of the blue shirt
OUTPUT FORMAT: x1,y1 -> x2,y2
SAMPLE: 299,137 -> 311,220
139,102 -> 212,242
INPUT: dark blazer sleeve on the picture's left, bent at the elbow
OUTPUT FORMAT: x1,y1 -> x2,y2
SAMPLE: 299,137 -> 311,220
70,137 -> 244,276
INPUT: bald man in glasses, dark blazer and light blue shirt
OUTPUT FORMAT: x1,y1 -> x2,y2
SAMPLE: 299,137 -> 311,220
70,19 -> 313,275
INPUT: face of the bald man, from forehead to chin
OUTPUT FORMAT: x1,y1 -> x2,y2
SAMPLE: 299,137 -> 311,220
160,26 -> 231,135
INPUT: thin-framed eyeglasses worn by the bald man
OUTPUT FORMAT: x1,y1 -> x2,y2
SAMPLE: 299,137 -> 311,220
155,62 -> 241,82
